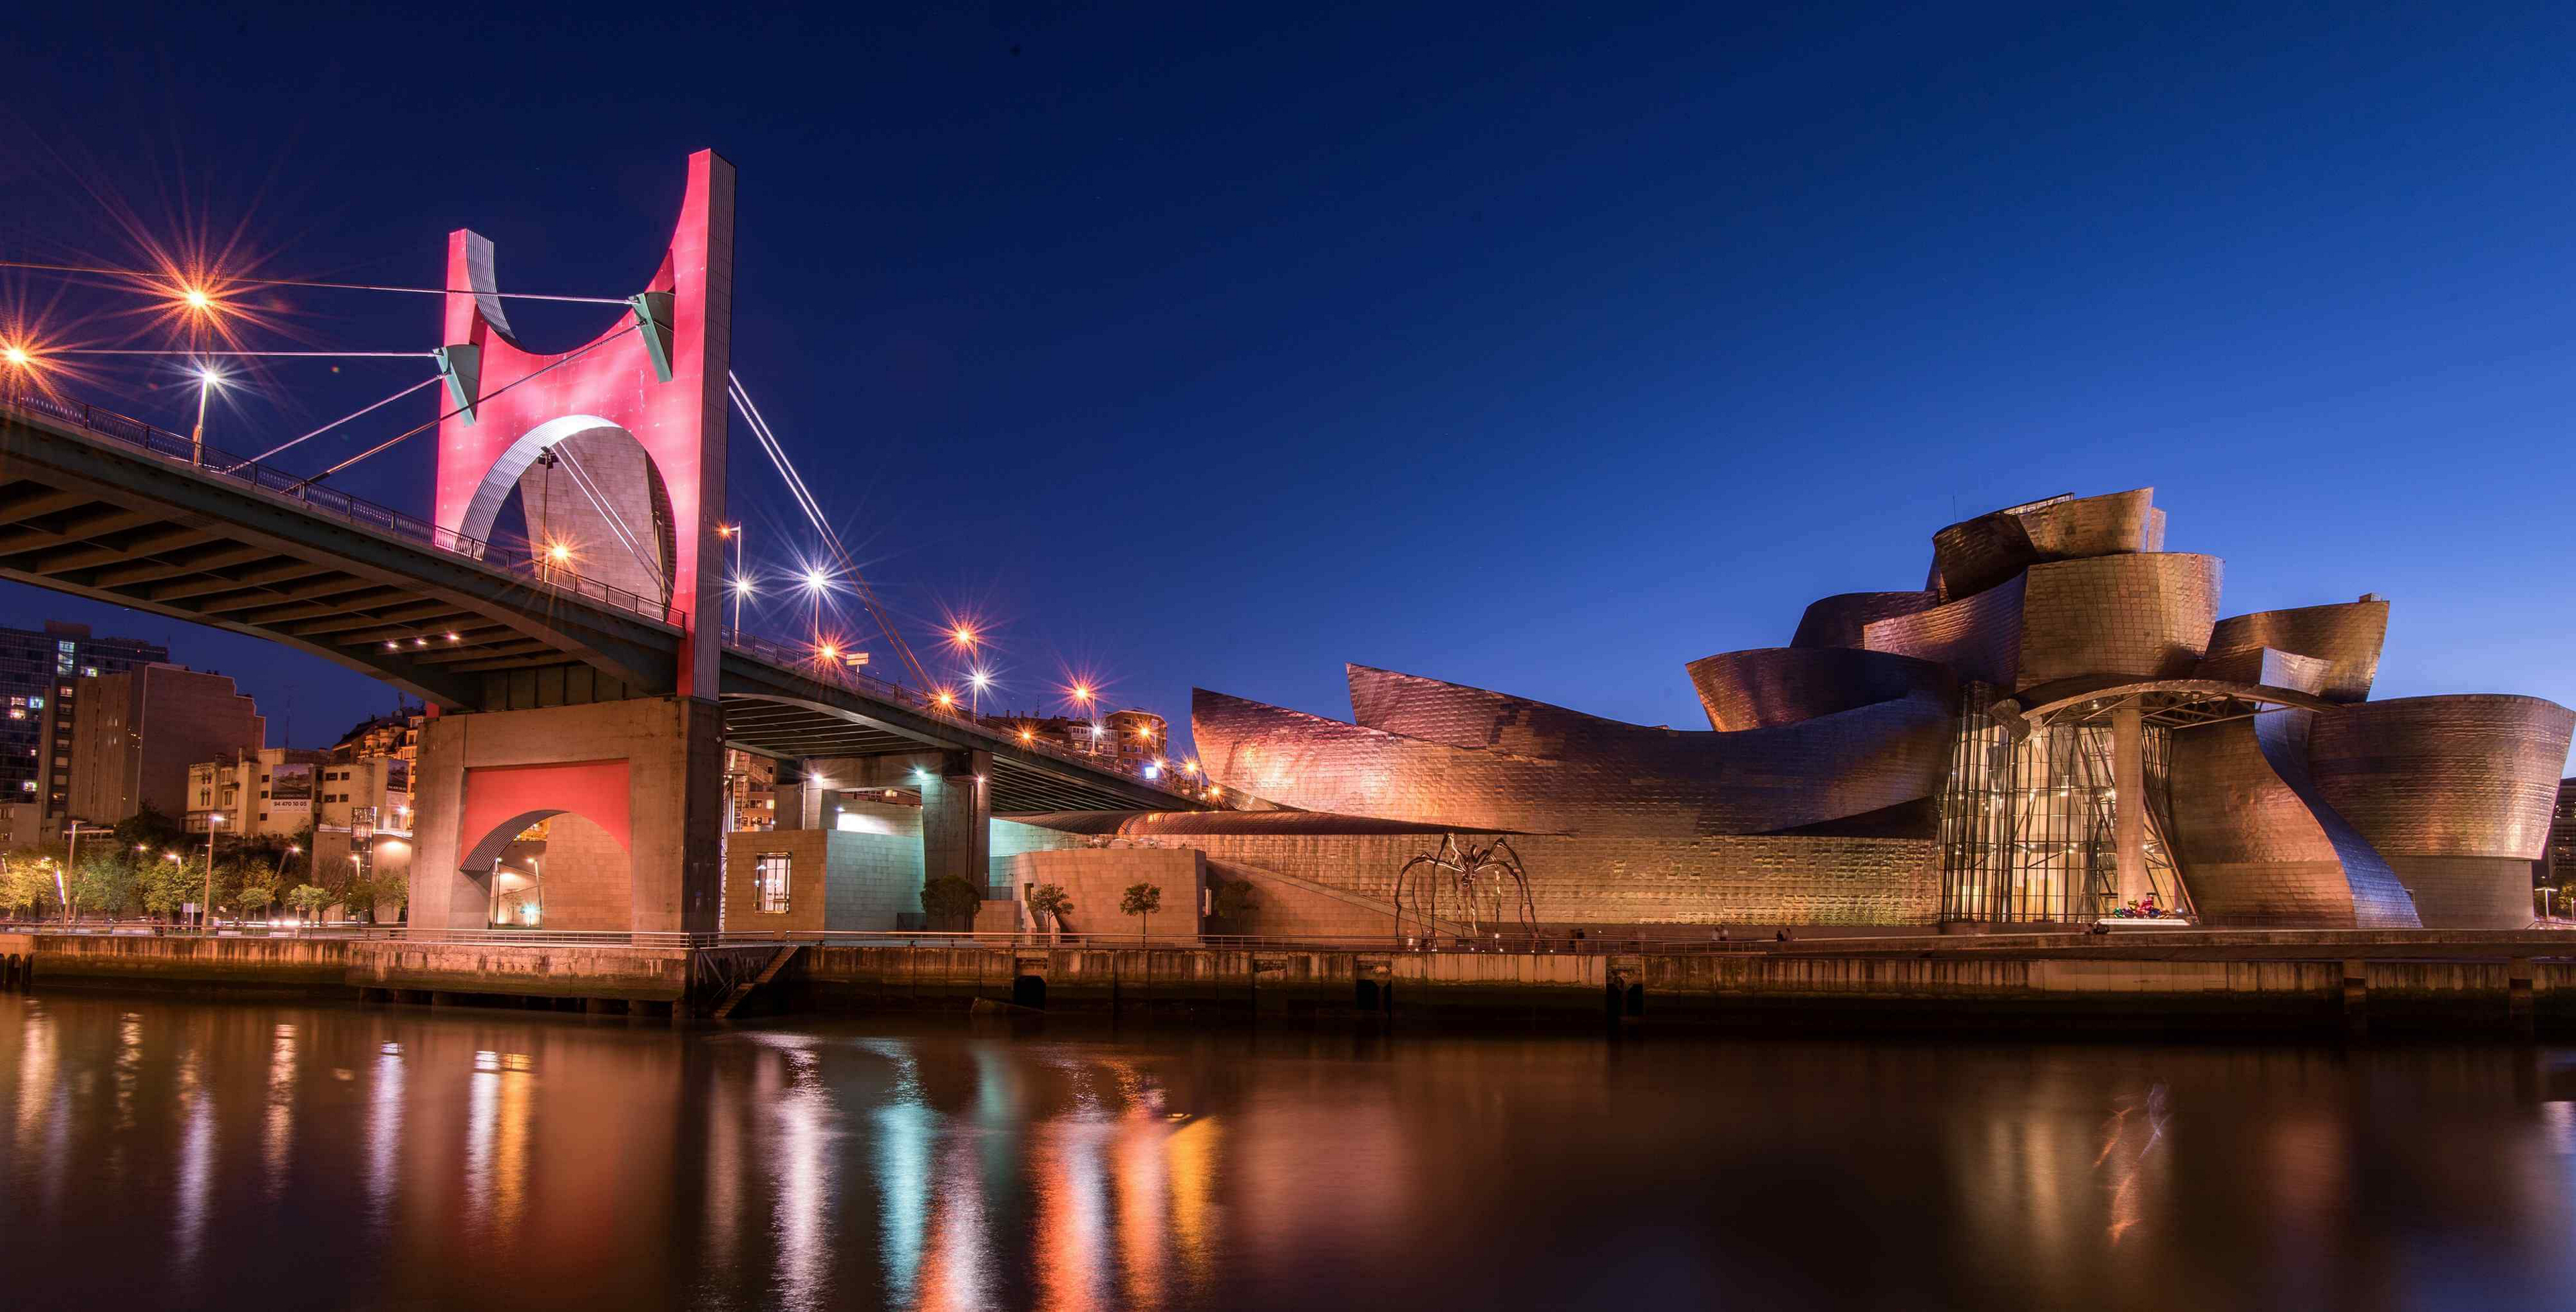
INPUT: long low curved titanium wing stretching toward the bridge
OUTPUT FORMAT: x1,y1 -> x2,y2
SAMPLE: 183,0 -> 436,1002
1190,688 -> 1950,835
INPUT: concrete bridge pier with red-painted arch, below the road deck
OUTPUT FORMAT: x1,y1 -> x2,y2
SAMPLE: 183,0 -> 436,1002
410,696 -> 724,933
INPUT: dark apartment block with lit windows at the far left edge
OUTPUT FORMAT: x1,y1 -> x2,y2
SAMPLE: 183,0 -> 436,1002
0,621 -> 170,835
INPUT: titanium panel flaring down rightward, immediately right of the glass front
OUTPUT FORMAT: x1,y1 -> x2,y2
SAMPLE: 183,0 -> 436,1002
2169,712 -> 2416,928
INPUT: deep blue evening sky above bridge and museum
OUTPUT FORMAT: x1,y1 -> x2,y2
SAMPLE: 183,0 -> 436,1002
0,3 -> 2576,745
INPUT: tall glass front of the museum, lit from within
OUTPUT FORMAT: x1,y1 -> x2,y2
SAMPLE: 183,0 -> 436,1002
1940,683 -> 2184,923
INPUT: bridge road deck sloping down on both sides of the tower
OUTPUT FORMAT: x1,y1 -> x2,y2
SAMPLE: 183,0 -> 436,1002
0,394 -> 1205,814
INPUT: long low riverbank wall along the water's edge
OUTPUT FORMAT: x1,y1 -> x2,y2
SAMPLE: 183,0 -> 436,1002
15,933 -> 2576,1036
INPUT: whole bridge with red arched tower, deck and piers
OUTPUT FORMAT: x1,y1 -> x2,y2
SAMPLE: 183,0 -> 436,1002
0,152 -> 1205,933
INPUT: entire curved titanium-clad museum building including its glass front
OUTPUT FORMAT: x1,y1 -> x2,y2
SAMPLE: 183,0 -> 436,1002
1193,490 -> 2576,928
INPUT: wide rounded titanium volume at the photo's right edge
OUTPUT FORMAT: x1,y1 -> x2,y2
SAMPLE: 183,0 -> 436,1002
2310,694 -> 2576,861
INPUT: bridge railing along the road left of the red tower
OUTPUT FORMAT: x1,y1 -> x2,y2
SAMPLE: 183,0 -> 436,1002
0,392 -> 675,624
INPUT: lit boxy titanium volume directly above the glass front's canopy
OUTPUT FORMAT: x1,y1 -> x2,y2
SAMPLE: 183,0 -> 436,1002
1998,551 -> 2220,688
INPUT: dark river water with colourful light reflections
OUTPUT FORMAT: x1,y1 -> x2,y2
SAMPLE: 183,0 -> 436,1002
0,992 -> 2576,1309
